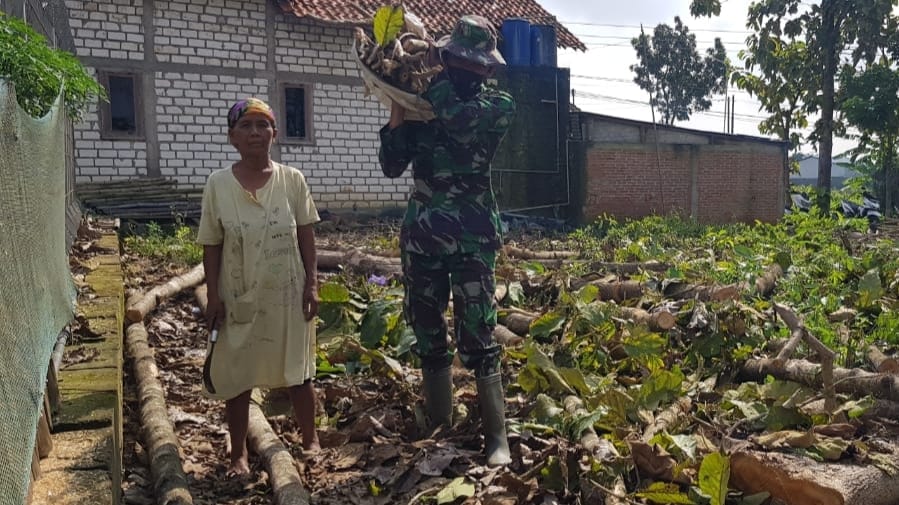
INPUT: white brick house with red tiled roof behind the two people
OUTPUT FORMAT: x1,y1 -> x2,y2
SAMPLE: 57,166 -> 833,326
65,0 -> 584,209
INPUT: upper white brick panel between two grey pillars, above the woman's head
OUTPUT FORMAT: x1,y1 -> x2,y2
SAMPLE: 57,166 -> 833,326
154,0 -> 268,70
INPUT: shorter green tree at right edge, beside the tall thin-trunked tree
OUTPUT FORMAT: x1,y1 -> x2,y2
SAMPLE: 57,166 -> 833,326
838,59 -> 899,213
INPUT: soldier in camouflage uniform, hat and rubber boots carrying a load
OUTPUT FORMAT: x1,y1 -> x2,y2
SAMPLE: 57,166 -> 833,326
379,16 -> 515,466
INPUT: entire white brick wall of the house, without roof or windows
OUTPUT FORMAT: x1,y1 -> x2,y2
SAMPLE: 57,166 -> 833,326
66,0 -> 411,209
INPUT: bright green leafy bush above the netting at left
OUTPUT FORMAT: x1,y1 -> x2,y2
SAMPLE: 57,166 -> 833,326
0,12 -> 106,120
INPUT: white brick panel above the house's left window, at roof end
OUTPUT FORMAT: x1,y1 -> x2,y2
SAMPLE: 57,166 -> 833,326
66,0 -> 144,60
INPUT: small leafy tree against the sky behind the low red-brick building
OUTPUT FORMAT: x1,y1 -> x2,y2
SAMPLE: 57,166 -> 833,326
631,17 -> 728,125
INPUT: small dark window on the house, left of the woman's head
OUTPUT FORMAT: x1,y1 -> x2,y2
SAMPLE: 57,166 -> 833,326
100,73 -> 143,139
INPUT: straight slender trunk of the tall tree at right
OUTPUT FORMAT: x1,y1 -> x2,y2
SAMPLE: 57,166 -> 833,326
817,0 -> 838,211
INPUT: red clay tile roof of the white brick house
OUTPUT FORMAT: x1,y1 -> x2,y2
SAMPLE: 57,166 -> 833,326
278,0 -> 587,51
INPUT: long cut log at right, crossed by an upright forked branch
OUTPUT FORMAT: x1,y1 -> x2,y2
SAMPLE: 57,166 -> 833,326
738,359 -> 899,402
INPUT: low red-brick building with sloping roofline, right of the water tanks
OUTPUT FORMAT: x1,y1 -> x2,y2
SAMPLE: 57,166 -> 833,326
575,113 -> 789,223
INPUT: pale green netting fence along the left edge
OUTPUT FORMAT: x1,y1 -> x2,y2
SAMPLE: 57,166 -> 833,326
0,80 -> 75,504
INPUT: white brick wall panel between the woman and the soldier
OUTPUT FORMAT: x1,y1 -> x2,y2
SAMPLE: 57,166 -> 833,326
281,84 -> 411,209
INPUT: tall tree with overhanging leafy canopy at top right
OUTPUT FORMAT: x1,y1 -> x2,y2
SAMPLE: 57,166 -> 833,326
748,0 -> 897,209
